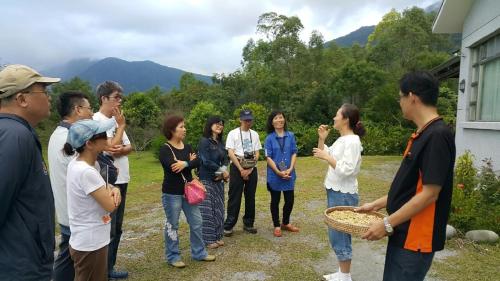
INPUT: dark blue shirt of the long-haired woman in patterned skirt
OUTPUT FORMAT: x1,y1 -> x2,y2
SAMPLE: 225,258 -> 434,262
198,137 -> 229,180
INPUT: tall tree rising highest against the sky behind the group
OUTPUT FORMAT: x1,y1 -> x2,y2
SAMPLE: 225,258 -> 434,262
242,12 -> 308,111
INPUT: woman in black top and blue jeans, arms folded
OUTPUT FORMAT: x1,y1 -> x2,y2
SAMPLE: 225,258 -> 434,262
160,115 -> 215,268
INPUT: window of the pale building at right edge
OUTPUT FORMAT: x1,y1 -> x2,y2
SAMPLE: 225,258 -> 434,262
468,35 -> 500,121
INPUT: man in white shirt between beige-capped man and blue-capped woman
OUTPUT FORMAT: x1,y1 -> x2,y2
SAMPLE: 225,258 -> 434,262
48,92 -> 93,281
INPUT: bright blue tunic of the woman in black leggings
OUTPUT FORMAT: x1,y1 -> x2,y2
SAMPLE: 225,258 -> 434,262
265,131 -> 297,191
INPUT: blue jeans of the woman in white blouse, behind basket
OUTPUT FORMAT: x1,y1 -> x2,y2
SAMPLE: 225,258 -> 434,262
326,189 -> 359,261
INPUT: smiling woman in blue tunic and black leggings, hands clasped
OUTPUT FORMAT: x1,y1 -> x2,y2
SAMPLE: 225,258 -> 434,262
265,111 -> 299,237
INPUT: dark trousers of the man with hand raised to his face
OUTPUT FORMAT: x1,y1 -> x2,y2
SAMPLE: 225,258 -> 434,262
108,183 -> 128,272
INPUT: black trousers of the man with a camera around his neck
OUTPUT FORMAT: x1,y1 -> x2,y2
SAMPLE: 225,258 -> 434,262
224,164 -> 258,230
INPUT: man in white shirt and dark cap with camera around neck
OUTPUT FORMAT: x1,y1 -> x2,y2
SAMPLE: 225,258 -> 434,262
224,109 -> 262,236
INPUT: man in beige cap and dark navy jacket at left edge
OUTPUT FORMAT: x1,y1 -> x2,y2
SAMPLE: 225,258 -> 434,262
0,65 -> 60,280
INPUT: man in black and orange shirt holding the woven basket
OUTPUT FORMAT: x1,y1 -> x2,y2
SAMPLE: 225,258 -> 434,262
358,71 -> 455,281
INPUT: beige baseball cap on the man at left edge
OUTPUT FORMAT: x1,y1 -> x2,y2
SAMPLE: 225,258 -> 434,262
0,64 -> 61,98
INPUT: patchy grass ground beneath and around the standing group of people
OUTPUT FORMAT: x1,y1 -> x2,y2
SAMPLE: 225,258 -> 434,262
107,152 -> 500,281
